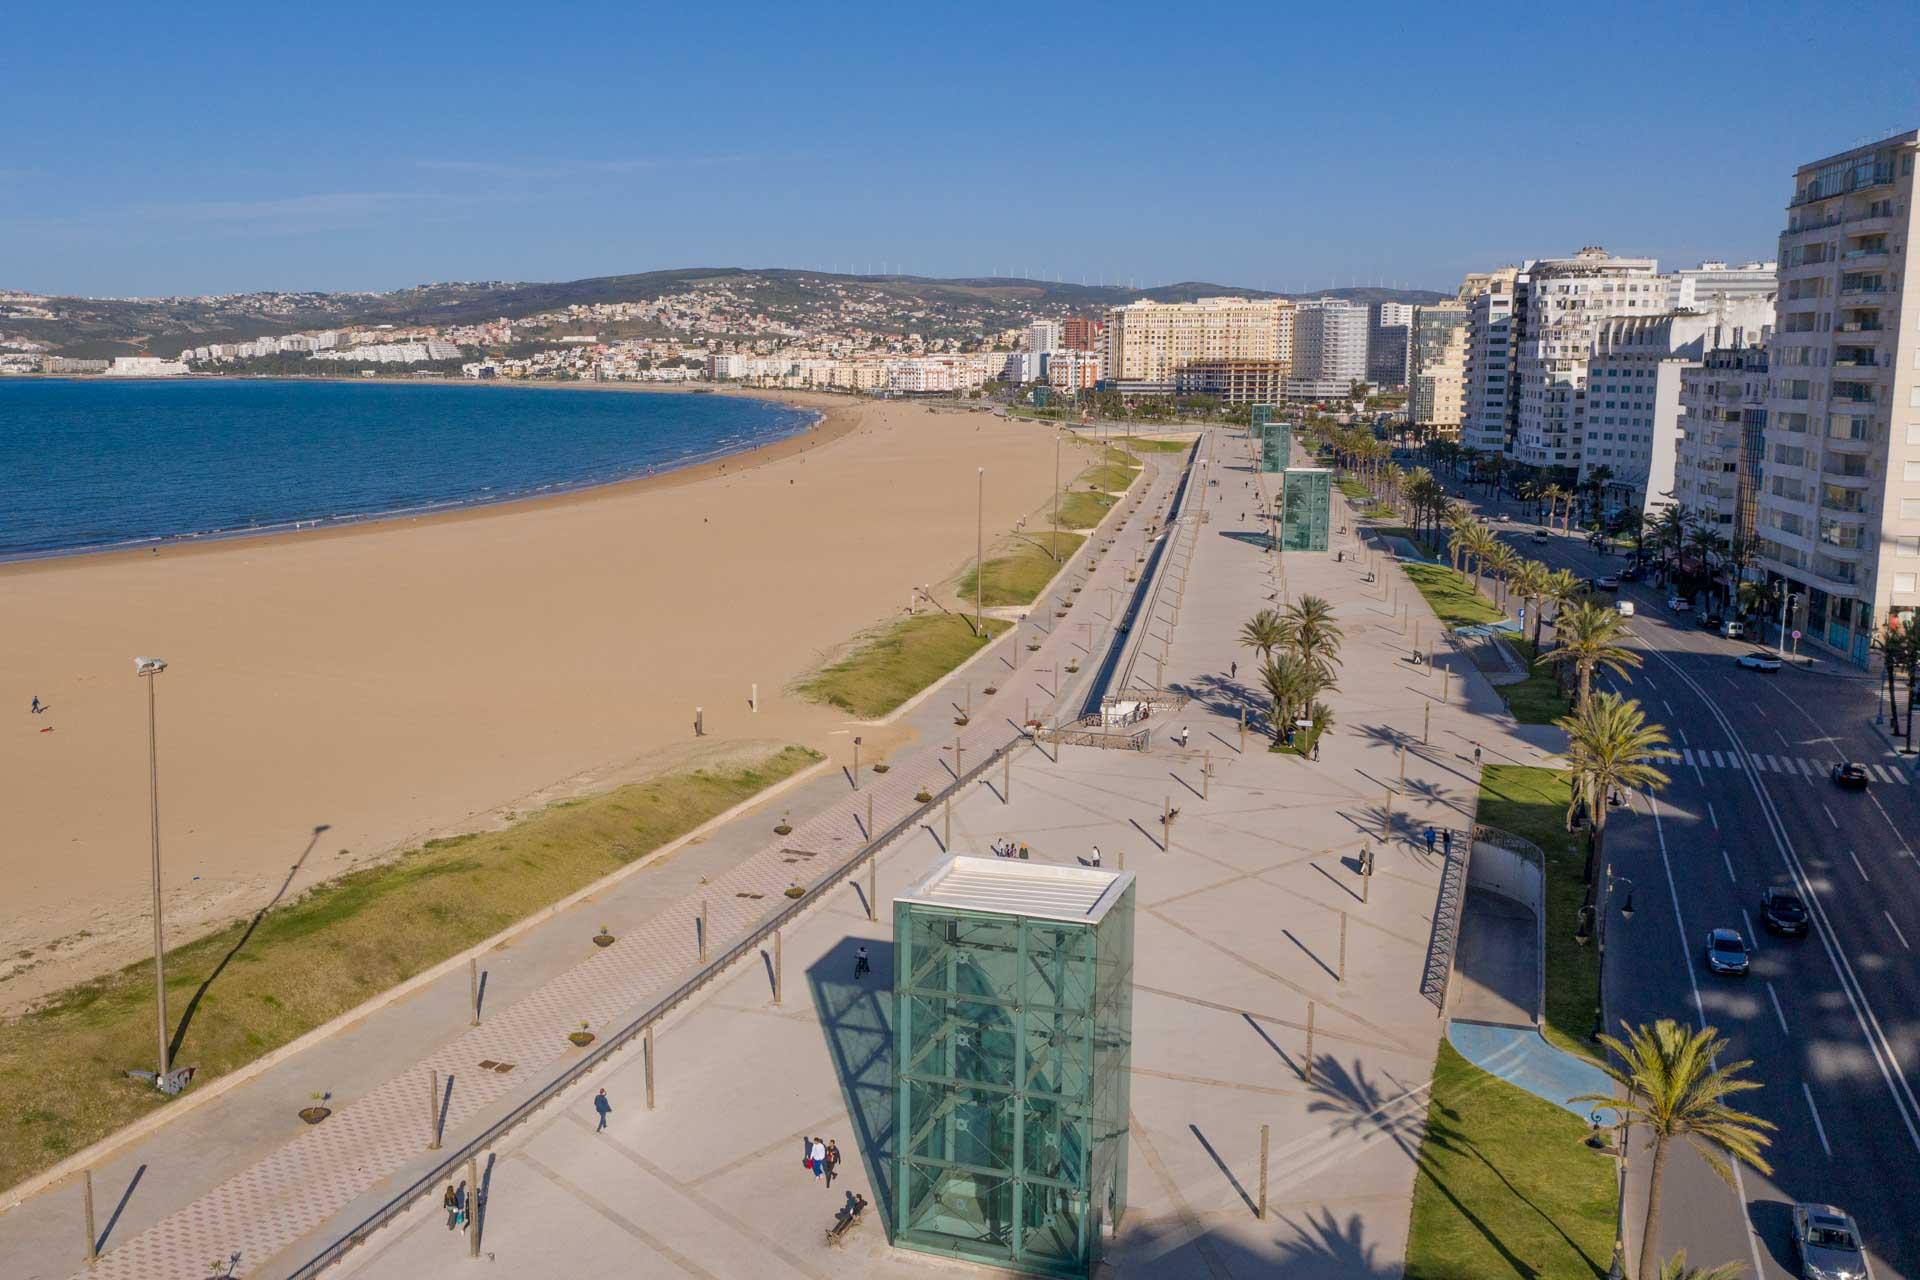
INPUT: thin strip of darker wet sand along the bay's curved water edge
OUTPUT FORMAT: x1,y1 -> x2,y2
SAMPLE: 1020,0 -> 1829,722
0,383 -> 858,576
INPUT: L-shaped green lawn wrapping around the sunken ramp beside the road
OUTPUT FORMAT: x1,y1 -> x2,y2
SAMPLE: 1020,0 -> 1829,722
1475,764 -> 1599,1061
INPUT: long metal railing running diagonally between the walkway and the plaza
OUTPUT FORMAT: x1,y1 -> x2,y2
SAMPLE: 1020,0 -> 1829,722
290,733 -> 1031,1280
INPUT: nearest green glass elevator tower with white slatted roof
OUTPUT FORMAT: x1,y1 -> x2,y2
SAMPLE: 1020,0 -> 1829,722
891,858 -> 1133,1276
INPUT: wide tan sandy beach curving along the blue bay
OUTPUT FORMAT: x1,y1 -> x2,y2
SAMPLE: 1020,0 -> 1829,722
0,393 -> 1085,1009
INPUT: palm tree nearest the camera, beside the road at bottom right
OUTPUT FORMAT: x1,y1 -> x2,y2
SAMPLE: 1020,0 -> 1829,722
1567,1017 -> 1774,1276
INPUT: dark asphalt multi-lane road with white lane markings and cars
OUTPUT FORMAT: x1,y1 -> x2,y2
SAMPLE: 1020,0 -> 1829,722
1443,483 -> 1920,1280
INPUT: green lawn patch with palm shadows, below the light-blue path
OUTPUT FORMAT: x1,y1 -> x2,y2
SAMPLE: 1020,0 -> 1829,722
1405,1040 -> 1619,1280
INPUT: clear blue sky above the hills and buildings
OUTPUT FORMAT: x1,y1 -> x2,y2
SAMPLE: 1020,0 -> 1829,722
0,0 -> 1920,294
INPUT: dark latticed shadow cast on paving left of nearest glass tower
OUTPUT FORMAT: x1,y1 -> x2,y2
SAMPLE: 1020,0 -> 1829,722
806,938 -> 895,1238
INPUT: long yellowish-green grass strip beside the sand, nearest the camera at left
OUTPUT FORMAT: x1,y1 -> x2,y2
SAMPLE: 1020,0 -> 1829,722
0,747 -> 820,1186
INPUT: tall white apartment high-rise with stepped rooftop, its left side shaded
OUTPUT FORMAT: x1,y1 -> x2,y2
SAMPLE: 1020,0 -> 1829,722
1511,248 -> 1668,468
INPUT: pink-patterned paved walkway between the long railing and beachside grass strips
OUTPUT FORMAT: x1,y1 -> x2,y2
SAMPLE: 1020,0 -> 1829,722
0,454 -> 1179,1280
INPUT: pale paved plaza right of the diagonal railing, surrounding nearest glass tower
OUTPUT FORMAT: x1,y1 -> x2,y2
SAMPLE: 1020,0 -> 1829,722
303,439 -> 1528,1280
